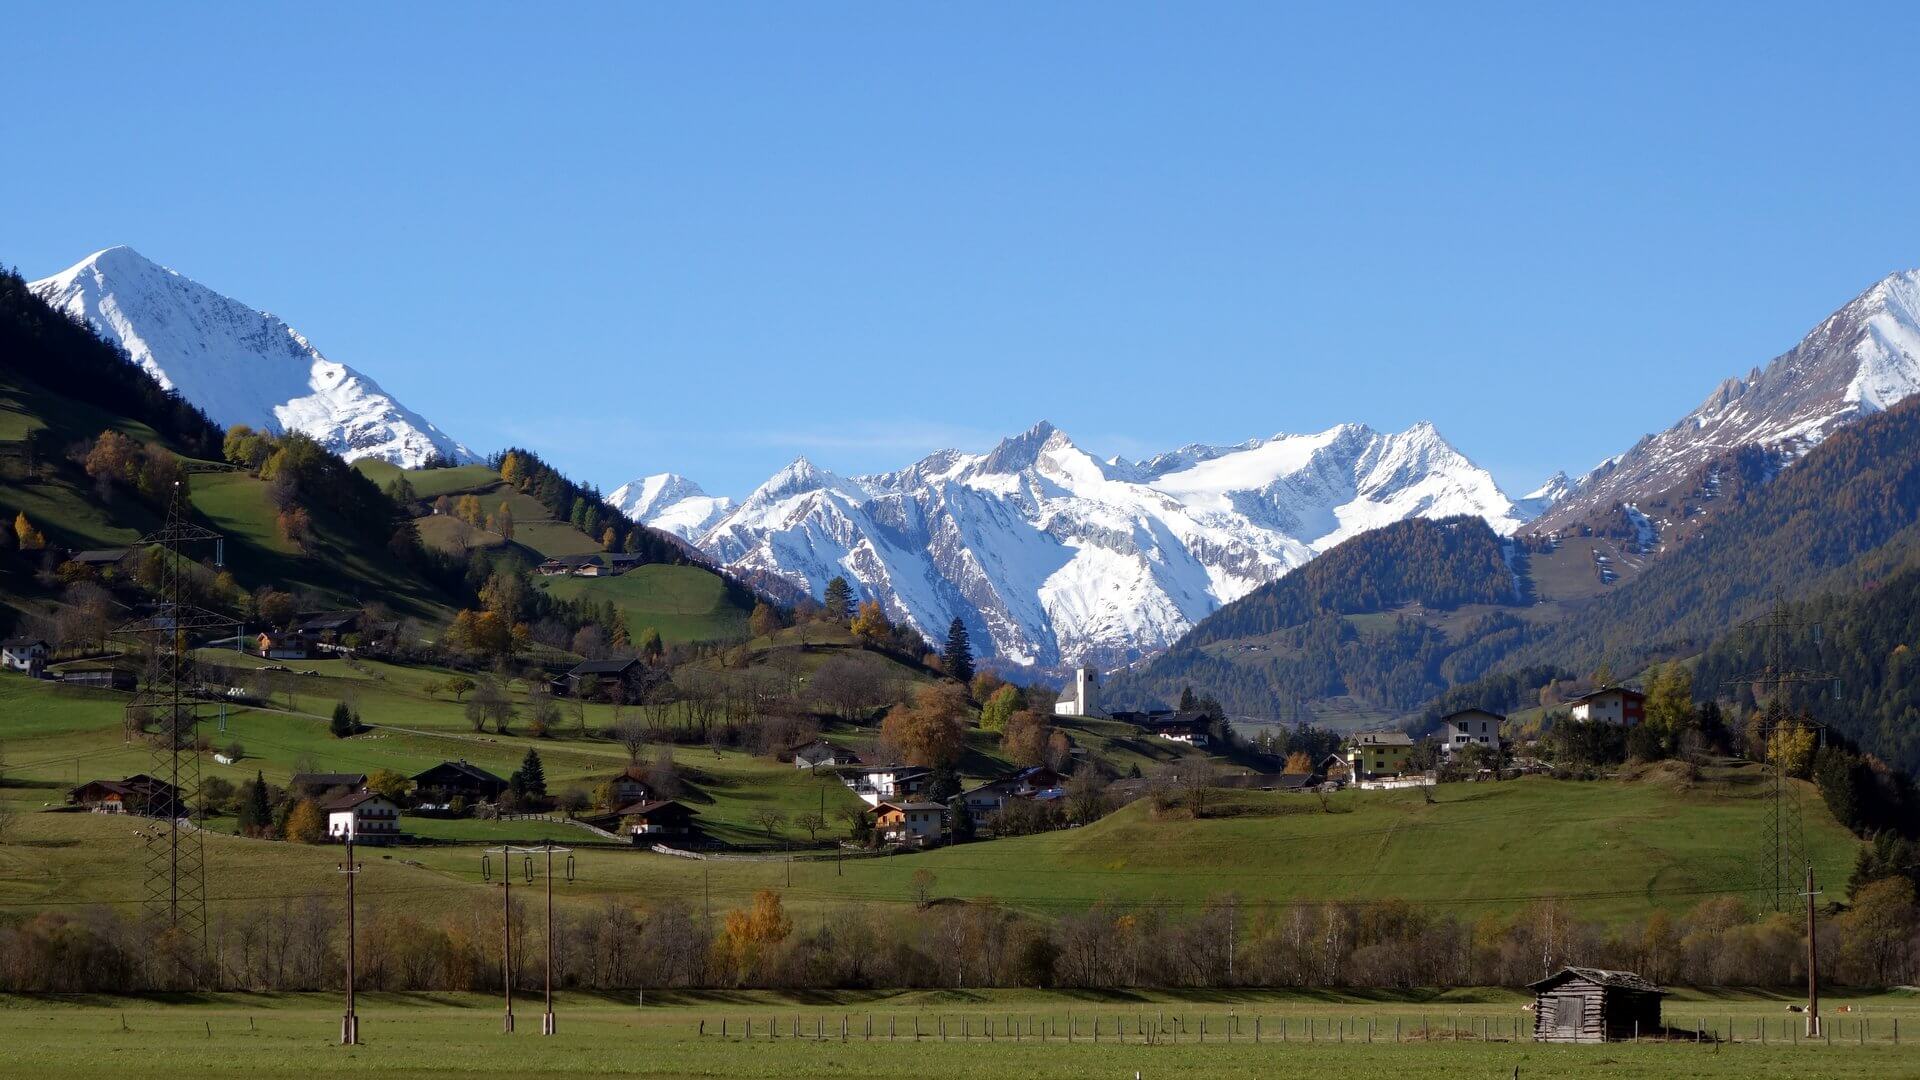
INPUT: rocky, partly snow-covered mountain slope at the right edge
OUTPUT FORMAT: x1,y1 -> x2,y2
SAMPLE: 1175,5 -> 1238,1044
1534,271 -> 1920,530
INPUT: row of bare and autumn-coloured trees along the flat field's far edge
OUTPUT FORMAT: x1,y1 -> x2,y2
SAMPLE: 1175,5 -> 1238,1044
0,871 -> 1920,994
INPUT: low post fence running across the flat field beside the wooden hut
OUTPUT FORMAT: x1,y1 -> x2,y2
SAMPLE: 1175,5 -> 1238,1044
697,1011 -> 1901,1047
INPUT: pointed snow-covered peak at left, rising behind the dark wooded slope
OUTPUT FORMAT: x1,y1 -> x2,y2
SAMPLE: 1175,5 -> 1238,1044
31,248 -> 478,467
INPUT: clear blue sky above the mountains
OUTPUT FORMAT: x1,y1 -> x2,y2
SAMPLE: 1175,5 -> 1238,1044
0,2 -> 1920,494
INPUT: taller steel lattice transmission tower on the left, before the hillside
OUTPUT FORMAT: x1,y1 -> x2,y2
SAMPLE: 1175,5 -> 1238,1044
115,478 -> 234,955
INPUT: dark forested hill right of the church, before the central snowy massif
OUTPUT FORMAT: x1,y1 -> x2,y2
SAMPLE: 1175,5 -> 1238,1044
1108,517 -> 1528,721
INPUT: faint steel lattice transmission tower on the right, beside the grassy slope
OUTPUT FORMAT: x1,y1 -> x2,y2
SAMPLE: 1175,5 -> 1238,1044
1726,607 -> 1839,911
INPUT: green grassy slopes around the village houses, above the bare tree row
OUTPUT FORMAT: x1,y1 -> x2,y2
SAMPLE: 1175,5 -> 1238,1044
0,661 -> 1857,920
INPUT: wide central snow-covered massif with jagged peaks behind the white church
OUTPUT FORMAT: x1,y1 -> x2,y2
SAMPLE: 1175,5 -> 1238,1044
652,423 -> 1526,667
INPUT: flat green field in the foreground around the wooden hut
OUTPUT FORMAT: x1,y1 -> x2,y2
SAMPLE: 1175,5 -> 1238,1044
0,990 -> 1920,1080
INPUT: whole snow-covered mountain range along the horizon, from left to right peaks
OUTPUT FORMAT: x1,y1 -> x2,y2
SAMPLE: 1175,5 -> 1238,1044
31,248 -> 1920,669
